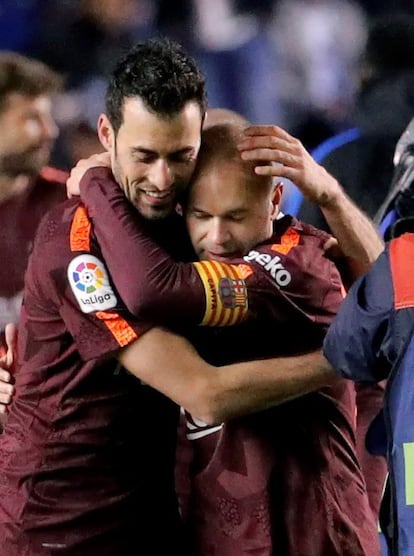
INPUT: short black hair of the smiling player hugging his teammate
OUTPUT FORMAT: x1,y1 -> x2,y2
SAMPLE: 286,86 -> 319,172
106,38 -> 207,133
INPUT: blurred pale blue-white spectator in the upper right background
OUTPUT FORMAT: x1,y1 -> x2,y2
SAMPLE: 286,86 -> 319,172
270,0 -> 366,149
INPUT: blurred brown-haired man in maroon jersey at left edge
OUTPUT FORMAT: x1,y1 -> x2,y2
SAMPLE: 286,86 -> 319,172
0,52 -> 67,348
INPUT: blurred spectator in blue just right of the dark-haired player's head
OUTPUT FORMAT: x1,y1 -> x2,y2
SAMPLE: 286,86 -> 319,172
156,0 -> 282,124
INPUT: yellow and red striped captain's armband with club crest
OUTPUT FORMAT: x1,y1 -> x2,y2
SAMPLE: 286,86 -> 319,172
193,261 -> 248,326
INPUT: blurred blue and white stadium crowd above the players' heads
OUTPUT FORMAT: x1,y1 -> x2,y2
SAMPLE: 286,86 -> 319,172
0,0 -> 414,168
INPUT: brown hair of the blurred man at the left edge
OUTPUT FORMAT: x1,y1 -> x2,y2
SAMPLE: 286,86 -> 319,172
0,51 -> 63,110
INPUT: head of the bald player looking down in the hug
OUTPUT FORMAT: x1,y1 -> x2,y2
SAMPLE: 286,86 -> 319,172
185,122 -> 281,260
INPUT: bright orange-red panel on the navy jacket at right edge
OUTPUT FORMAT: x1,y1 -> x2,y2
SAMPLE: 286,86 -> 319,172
390,230 -> 414,309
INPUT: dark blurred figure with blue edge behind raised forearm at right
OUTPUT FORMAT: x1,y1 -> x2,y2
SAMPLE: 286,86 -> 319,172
299,13 -> 414,230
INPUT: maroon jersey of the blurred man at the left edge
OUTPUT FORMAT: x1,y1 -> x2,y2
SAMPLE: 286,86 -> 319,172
0,168 -> 67,331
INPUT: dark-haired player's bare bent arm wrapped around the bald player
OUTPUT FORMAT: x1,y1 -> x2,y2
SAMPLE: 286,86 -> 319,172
119,328 -> 338,424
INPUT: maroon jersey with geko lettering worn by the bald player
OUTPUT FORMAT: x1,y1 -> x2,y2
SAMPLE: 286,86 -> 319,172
81,169 -> 379,556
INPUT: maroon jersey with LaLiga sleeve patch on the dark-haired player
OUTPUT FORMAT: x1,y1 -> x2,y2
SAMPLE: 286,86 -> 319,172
0,201 -> 184,556
